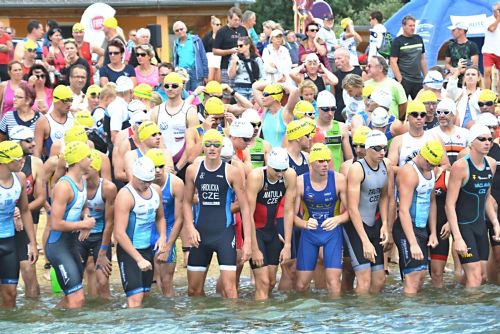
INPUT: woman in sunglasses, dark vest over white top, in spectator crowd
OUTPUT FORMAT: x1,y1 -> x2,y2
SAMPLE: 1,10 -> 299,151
228,36 -> 264,100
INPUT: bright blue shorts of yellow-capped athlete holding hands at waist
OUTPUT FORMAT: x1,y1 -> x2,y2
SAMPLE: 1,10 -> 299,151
297,227 -> 343,271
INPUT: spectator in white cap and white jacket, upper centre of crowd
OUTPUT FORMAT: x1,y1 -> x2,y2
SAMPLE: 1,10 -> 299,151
262,30 -> 292,83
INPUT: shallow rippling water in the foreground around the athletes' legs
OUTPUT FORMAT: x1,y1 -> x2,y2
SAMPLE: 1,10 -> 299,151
0,274 -> 500,334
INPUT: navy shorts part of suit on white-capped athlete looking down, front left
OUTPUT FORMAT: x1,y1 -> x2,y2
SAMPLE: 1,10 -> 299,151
116,245 -> 154,297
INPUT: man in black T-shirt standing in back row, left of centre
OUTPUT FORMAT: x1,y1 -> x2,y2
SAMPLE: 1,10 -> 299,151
212,7 -> 248,83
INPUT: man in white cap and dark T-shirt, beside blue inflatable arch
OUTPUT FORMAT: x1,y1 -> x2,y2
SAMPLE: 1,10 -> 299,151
444,22 -> 479,87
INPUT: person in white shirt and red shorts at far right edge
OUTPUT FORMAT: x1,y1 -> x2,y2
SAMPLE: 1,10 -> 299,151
482,2 -> 500,94
